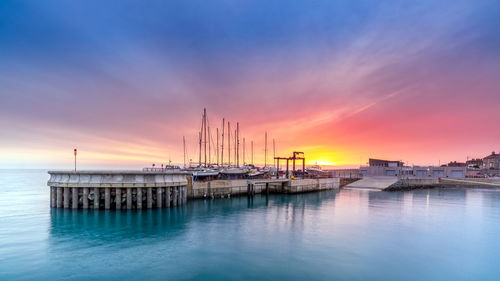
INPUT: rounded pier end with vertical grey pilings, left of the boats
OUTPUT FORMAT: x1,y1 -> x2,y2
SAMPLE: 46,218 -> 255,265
47,171 -> 188,210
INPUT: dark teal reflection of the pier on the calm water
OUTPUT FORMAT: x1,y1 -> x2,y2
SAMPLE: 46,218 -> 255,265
49,191 -> 338,244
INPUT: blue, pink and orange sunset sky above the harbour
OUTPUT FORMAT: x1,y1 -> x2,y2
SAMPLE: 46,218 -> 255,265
0,0 -> 500,169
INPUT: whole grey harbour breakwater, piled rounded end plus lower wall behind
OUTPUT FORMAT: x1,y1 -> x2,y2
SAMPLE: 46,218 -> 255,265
47,171 -> 340,210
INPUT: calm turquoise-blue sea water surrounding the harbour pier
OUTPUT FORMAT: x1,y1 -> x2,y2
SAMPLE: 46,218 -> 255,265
0,170 -> 500,280
